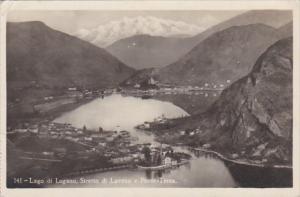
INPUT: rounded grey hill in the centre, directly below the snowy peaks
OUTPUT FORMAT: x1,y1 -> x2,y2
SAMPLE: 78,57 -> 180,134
106,35 -> 190,69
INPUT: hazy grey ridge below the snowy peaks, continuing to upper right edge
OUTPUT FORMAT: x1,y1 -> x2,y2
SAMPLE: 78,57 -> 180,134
106,10 -> 292,69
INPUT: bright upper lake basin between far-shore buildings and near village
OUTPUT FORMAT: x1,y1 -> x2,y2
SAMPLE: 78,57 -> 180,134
54,94 -> 189,143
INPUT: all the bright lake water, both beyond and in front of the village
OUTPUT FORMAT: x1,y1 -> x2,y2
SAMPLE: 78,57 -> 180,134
54,94 -> 237,187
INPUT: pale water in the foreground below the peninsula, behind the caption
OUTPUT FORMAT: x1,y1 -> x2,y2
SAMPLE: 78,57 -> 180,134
58,154 -> 237,187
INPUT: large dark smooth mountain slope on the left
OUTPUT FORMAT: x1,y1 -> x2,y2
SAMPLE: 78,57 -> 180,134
7,22 -> 134,100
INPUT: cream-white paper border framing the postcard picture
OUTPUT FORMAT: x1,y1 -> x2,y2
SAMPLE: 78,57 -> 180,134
0,0 -> 300,197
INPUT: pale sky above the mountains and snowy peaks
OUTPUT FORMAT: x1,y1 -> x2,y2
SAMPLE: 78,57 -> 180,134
7,10 -> 245,34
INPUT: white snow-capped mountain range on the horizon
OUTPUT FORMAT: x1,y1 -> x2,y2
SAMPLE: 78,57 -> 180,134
74,16 -> 204,47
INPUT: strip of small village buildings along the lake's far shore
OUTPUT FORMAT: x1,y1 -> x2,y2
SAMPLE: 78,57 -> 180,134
7,77 -> 231,113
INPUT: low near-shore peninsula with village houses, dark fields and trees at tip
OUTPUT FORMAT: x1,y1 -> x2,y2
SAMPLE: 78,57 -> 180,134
7,118 -> 190,179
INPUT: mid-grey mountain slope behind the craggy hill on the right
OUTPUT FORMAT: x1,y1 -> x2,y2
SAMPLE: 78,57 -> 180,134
123,21 -> 291,87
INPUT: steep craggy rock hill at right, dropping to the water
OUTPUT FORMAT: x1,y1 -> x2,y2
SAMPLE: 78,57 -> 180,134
164,38 -> 293,165
